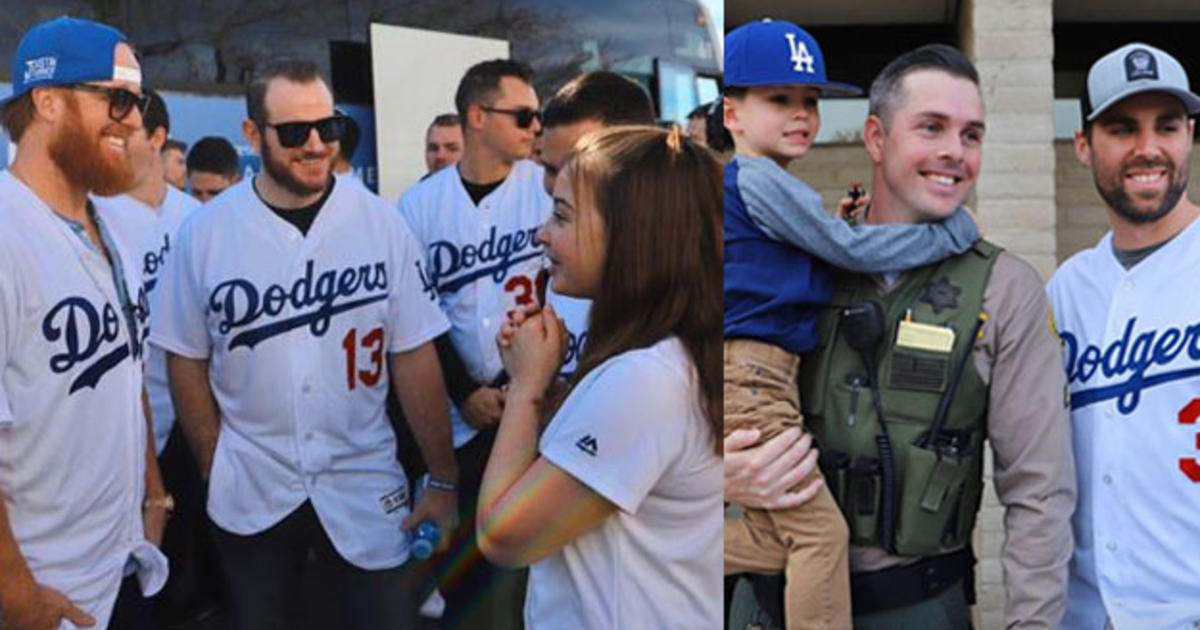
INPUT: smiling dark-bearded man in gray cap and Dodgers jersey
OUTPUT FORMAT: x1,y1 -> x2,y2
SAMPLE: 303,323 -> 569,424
1048,43 -> 1200,630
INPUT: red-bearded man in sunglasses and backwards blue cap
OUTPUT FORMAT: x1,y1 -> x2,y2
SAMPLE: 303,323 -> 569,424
0,18 -> 168,630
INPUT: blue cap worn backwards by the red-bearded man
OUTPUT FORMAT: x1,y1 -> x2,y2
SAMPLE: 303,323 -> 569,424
4,17 -> 142,104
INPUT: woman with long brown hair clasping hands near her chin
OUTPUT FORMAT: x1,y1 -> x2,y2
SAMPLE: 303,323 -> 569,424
476,127 -> 724,630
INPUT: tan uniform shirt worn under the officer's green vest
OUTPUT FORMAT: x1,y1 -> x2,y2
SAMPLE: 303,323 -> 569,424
850,252 -> 1075,629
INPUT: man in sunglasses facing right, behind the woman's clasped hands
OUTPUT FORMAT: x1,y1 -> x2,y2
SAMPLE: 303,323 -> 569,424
400,59 -> 552,629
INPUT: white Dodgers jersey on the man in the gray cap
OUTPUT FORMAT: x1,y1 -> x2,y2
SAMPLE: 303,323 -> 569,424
1049,221 -> 1200,630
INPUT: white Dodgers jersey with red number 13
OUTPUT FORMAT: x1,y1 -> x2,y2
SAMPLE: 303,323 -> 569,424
150,176 -> 448,569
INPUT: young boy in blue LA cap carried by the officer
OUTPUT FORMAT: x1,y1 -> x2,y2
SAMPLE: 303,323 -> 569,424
725,19 -> 979,629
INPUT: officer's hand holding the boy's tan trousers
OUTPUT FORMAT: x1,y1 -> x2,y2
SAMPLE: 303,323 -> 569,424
724,428 -> 823,510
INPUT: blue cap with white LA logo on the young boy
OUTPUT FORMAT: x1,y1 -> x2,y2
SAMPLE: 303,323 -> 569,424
725,18 -> 863,96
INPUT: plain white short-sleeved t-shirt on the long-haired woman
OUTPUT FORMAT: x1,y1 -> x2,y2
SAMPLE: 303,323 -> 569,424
524,337 -> 725,630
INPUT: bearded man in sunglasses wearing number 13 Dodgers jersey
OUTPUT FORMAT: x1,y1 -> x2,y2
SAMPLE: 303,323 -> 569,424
150,60 -> 457,630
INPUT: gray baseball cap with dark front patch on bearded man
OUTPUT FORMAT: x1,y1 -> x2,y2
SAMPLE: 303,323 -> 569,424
1079,42 -> 1200,124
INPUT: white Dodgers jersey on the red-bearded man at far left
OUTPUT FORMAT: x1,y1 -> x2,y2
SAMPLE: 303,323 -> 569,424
0,172 -> 167,628
